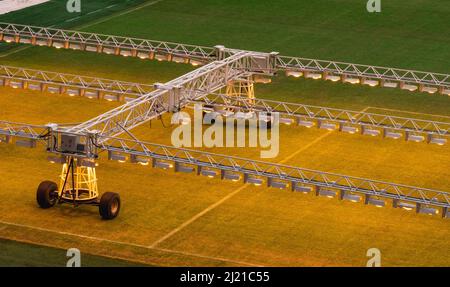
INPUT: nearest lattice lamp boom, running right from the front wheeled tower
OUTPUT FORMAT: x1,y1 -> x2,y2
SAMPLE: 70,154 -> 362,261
101,137 -> 450,207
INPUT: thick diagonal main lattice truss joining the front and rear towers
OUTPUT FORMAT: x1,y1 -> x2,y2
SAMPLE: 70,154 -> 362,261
63,52 -> 260,140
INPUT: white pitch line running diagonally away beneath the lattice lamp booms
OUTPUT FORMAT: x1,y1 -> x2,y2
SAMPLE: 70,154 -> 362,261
150,107 -> 369,248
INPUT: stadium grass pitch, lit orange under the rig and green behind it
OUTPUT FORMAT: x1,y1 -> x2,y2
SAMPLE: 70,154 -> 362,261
0,0 -> 450,266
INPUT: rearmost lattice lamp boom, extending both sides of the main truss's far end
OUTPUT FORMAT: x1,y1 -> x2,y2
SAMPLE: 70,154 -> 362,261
0,23 -> 450,93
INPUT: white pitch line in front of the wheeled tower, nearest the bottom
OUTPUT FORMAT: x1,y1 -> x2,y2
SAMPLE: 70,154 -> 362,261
0,220 -> 259,266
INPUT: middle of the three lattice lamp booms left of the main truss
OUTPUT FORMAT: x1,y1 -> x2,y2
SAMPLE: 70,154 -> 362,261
0,65 -> 154,97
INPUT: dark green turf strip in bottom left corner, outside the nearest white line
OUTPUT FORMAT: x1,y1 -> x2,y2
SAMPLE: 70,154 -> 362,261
0,239 -> 148,267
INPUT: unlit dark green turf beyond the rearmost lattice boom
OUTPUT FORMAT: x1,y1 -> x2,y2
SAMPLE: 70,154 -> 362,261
79,0 -> 450,73
